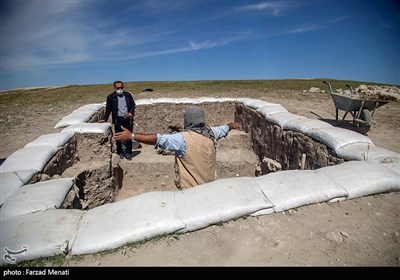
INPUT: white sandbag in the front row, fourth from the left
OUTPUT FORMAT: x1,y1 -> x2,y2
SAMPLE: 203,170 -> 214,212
253,170 -> 347,215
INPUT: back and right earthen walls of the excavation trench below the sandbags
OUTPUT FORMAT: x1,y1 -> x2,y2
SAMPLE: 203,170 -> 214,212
135,98 -> 344,174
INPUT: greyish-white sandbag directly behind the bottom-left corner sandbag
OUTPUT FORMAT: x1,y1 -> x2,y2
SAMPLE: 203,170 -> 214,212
0,178 -> 75,219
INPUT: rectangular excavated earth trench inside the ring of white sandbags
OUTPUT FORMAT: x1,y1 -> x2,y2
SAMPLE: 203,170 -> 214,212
32,102 -> 344,209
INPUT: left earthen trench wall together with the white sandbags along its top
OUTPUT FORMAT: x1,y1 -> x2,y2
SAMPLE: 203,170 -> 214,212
0,104 -> 123,209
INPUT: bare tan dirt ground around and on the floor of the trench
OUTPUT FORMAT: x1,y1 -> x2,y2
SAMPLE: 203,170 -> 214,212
0,89 -> 400,267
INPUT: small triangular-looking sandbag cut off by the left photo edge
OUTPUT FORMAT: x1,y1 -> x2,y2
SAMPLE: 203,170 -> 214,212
0,167 -> 38,205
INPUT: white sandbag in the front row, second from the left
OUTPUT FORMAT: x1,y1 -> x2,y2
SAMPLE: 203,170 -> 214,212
72,192 -> 185,254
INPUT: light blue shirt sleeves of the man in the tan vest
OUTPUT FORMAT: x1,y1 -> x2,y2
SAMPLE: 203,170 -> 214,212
156,124 -> 229,157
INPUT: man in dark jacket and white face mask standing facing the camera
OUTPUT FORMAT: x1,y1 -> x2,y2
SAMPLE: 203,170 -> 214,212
99,81 -> 136,160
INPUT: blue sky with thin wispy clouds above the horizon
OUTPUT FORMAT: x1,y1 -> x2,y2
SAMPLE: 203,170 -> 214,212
0,0 -> 400,90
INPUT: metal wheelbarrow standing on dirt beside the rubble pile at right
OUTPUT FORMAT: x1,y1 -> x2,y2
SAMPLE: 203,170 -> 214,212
323,81 -> 389,134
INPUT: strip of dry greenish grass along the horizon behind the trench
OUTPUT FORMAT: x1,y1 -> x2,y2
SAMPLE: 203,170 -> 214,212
0,79 -> 394,130
